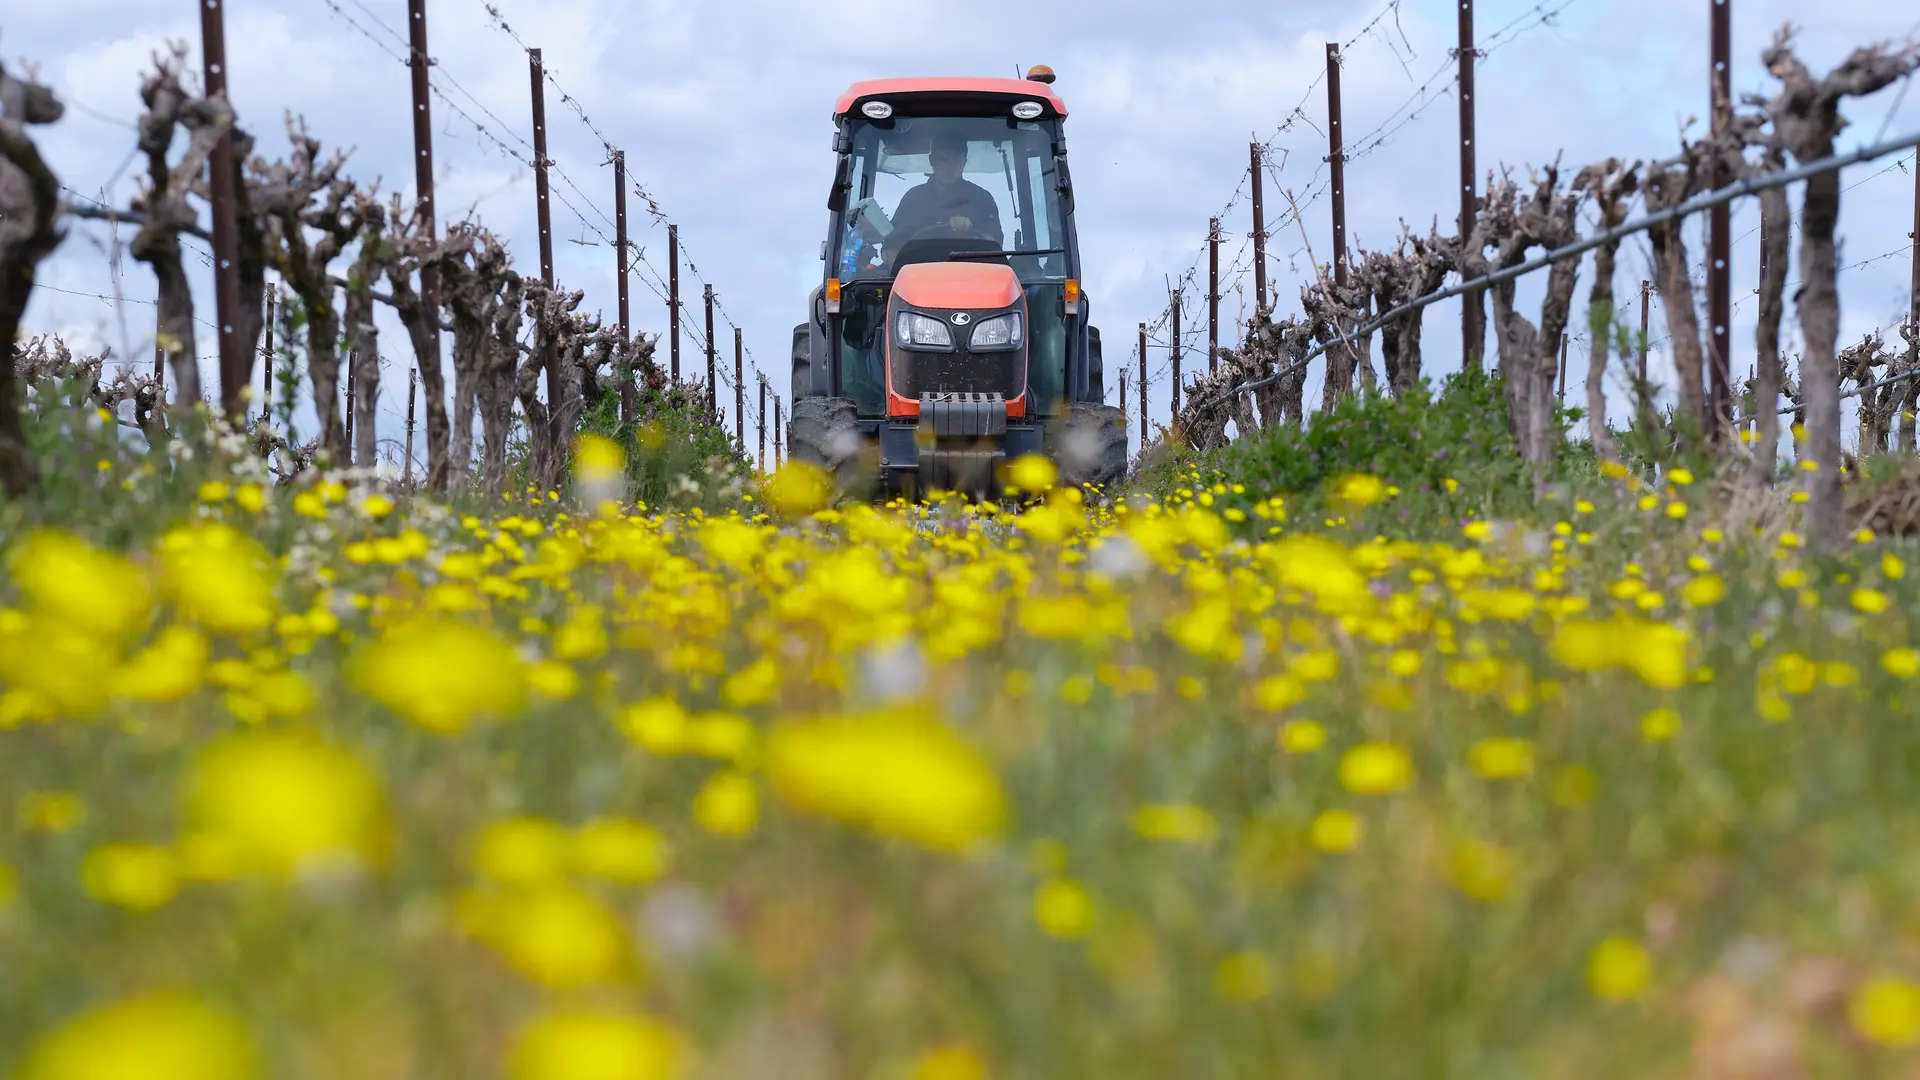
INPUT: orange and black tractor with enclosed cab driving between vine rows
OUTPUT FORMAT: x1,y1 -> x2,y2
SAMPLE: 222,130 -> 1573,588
787,67 -> 1127,500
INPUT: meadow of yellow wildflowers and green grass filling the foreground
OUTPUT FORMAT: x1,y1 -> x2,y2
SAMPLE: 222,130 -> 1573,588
0,405 -> 1920,1080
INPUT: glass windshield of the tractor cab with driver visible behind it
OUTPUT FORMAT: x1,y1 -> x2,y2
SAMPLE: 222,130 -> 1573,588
833,117 -> 1069,282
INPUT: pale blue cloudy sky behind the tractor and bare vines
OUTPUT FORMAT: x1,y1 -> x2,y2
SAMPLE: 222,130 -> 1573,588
15,0 -> 1920,457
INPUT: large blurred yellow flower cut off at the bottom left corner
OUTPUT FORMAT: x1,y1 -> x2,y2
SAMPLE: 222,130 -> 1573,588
17,994 -> 259,1080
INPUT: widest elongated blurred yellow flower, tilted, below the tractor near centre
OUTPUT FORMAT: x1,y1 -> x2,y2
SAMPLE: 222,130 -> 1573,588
766,717 -> 1006,851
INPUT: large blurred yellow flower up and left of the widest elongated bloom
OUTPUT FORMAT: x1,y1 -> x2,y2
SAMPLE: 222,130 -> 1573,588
351,619 -> 528,734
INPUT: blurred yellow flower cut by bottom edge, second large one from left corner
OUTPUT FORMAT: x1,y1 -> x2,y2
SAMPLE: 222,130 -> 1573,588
507,1009 -> 687,1080
